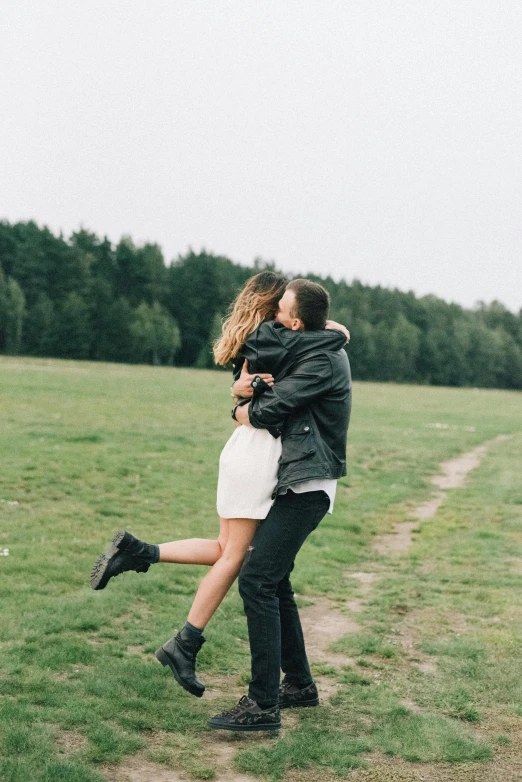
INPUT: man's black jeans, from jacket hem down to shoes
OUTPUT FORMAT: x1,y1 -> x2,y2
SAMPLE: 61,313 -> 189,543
239,490 -> 330,706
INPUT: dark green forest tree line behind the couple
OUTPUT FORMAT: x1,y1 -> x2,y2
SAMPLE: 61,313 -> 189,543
0,221 -> 522,389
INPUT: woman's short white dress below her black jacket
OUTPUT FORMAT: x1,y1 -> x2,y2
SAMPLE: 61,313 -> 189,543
217,426 -> 281,519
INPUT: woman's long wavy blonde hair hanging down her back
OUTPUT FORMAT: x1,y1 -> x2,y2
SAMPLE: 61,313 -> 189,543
214,271 -> 288,366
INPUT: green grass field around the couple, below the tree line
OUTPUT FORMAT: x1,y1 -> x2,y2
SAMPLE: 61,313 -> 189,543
0,357 -> 522,782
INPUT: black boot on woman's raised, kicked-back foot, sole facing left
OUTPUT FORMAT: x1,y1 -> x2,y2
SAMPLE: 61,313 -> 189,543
91,530 -> 159,589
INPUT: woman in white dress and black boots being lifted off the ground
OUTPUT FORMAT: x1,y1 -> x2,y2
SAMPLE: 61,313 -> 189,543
91,271 -> 346,697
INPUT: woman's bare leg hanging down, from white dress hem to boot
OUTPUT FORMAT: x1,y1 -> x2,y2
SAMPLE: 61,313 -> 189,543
187,519 -> 257,630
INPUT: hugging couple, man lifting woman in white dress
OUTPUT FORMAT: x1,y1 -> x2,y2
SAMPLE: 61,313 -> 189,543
91,271 -> 351,731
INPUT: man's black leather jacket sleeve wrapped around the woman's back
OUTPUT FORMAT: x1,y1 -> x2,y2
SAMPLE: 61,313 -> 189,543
248,353 -> 332,430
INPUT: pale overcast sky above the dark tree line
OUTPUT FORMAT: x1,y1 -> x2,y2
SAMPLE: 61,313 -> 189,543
0,0 -> 522,311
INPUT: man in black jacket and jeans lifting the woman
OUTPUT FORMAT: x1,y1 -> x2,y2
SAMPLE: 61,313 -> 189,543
208,280 -> 351,731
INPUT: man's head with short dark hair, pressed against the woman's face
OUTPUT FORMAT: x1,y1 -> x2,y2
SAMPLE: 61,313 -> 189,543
276,279 -> 330,331
